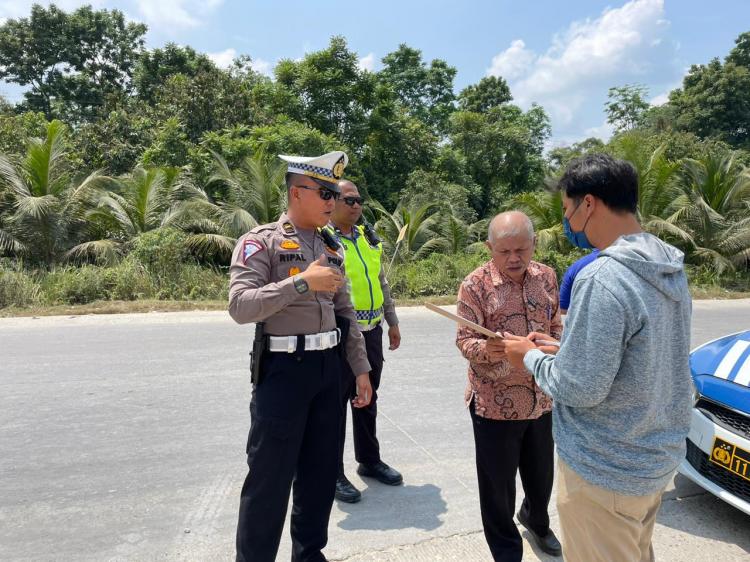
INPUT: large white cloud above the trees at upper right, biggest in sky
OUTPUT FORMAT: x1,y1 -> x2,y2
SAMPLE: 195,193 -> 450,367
487,0 -> 679,142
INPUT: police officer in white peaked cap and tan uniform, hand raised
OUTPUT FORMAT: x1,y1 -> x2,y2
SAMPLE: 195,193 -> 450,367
229,151 -> 372,562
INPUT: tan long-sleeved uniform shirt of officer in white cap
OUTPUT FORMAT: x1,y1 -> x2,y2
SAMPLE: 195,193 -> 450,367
229,214 -> 370,375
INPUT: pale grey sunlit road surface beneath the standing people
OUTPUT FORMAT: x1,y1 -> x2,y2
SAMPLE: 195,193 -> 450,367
0,300 -> 750,562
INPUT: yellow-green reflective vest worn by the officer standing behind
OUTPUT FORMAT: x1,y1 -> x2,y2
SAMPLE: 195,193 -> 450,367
335,226 -> 383,326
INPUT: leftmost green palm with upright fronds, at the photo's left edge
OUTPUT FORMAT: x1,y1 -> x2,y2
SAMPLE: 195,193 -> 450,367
0,121 -> 111,267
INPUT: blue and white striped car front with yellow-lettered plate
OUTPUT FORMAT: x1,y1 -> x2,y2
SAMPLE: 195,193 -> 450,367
678,330 -> 750,515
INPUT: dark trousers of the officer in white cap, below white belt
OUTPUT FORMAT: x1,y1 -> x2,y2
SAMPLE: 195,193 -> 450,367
237,349 -> 341,562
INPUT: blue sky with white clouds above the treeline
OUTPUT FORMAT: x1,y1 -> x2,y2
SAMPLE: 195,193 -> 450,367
0,0 -> 750,145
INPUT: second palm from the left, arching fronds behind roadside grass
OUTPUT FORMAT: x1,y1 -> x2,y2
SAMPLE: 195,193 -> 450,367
68,166 -> 206,263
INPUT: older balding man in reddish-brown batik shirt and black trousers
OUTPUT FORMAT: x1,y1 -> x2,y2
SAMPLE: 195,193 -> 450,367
456,212 -> 562,562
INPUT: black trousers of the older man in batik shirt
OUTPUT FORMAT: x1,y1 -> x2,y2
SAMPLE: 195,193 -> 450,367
469,403 -> 554,562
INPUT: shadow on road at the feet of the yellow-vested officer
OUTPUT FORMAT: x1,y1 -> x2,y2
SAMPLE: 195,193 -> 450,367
337,484 -> 448,531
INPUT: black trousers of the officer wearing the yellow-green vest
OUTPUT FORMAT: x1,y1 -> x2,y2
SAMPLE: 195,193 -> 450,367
338,325 -> 383,474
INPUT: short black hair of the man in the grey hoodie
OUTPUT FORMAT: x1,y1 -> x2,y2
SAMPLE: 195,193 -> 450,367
557,153 -> 638,214
